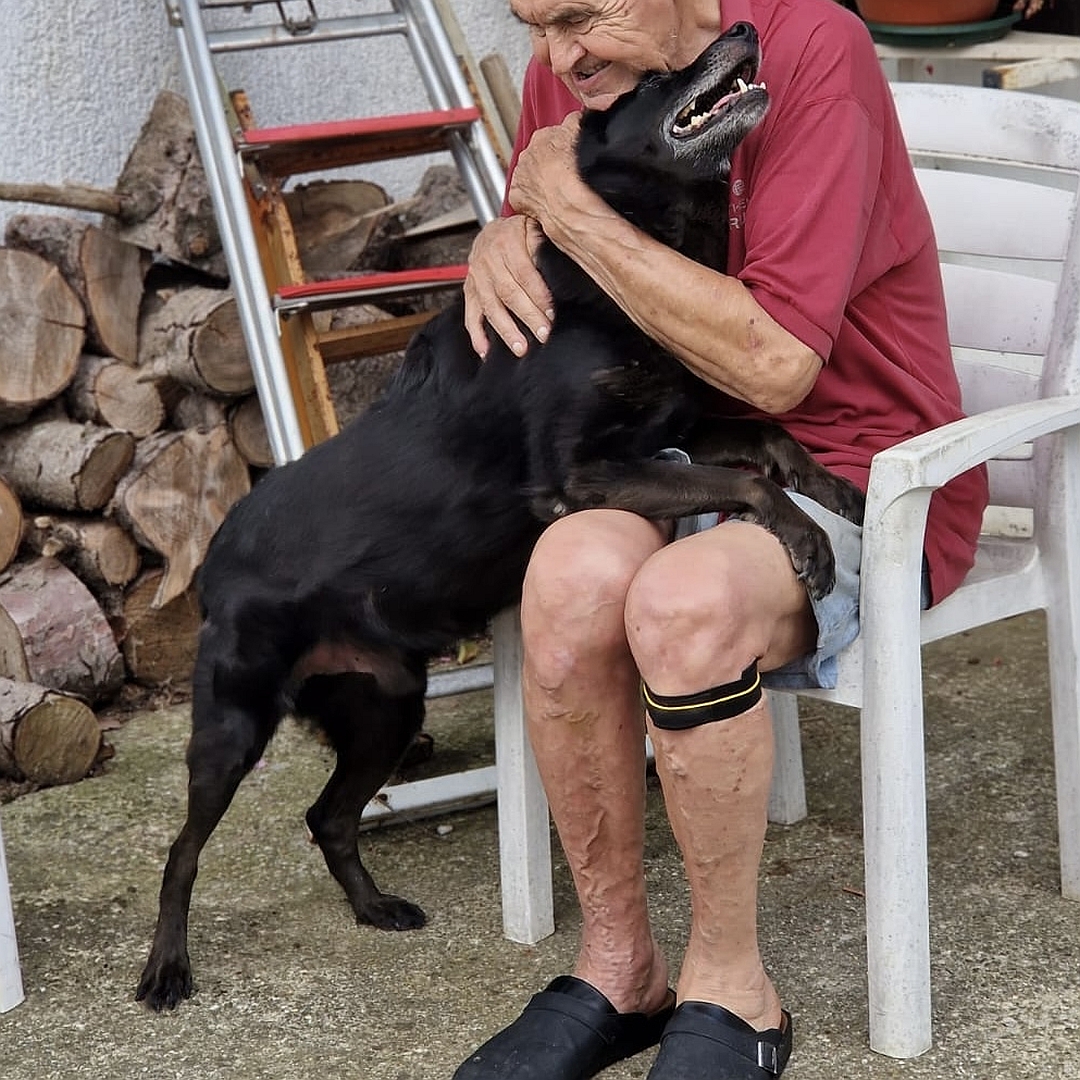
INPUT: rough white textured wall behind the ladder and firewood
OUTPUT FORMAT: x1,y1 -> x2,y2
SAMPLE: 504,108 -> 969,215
0,0 -> 528,235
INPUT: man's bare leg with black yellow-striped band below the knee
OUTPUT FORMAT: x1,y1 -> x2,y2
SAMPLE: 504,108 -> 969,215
626,523 -> 814,1030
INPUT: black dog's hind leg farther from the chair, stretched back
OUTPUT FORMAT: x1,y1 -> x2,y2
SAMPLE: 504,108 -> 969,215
135,627 -> 280,1012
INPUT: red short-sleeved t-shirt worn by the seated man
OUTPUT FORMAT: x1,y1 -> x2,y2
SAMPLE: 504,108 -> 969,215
504,0 -> 987,602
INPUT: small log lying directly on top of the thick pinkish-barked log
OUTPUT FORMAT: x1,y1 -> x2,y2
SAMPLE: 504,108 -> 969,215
24,514 -> 139,592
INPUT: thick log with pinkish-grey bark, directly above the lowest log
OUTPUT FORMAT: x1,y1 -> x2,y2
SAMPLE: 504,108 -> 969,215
0,558 -> 124,704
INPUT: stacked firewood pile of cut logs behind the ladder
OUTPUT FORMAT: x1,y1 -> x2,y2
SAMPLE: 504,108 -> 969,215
0,94 -> 477,784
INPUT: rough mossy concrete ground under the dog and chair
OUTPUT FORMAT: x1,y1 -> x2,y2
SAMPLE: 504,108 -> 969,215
0,617 -> 1080,1080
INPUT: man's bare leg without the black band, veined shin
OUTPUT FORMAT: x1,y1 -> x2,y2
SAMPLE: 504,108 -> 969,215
522,511 -> 667,1013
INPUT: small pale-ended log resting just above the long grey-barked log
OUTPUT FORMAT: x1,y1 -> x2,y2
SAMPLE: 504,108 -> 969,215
66,352 -> 165,438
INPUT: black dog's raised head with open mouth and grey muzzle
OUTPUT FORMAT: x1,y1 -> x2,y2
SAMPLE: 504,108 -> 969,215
578,23 -> 769,247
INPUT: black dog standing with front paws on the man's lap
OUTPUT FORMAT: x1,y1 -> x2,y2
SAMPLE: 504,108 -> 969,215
137,25 -> 862,1010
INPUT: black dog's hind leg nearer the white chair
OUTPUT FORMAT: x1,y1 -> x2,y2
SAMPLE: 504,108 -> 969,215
296,672 -> 427,930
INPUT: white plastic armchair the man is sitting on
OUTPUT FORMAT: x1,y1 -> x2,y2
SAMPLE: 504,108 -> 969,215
497,83 -> 1080,1057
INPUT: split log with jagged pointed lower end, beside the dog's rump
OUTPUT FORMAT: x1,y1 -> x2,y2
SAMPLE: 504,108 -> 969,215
109,427 -> 251,607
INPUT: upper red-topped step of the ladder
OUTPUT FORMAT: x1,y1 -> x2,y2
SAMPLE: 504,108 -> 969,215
245,108 -> 480,176
